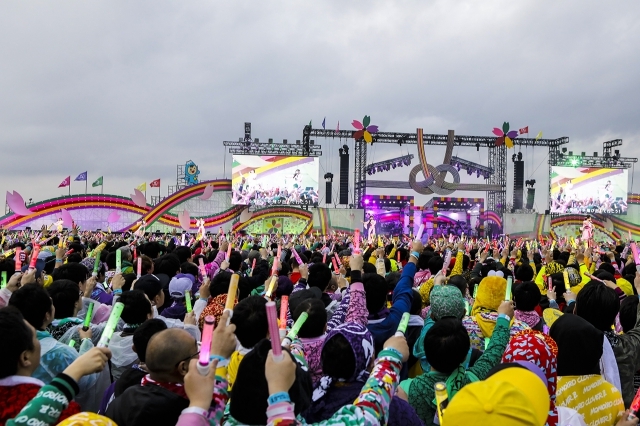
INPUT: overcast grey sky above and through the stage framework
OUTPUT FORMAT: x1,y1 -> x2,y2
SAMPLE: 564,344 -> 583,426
0,0 -> 640,215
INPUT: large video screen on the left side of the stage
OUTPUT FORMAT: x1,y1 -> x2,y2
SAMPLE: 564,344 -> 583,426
231,155 -> 320,207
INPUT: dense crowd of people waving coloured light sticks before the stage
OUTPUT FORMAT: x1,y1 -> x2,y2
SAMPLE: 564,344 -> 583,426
0,227 -> 640,426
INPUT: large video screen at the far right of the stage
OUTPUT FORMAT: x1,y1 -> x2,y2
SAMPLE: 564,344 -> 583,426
551,167 -> 629,215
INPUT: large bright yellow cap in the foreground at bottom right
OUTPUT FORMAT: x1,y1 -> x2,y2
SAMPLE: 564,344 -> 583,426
444,368 -> 549,426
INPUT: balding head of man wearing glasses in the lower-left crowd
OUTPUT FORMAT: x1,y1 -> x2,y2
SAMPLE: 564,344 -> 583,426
146,328 -> 198,378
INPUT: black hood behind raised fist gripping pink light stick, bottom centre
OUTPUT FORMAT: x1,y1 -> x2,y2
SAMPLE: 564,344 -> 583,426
229,339 -> 312,425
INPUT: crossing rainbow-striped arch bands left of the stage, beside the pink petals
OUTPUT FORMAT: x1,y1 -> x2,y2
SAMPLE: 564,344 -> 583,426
0,179 -> 245,232
